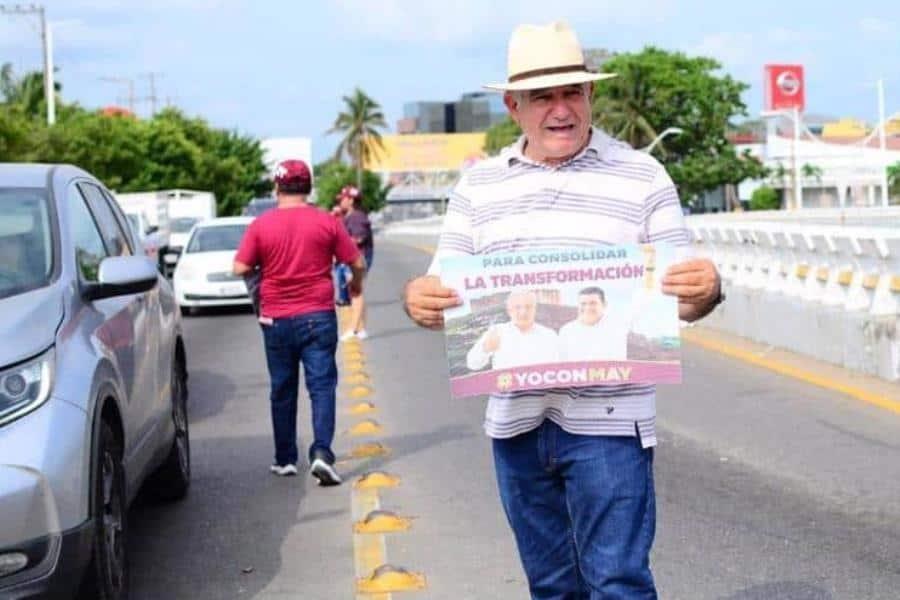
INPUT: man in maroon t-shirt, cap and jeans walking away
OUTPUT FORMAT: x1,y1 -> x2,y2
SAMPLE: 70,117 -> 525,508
234,160 -> 366,485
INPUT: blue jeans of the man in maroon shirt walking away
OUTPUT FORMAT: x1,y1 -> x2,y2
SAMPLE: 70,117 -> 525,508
262,311 -> 337,465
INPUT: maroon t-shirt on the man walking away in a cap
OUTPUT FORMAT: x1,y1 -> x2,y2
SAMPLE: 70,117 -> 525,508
235,205 -> 359,319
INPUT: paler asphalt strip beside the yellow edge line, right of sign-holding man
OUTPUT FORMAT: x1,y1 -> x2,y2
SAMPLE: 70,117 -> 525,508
657,344 -> 900,520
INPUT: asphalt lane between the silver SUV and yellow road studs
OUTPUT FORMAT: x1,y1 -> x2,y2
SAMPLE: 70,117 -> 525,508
128,310 -> 353,600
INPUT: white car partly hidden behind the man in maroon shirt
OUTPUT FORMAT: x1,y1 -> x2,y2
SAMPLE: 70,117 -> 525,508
173,217 -> 253,314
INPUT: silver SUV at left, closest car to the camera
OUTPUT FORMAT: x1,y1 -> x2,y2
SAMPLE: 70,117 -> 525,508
0,164 -> 191,600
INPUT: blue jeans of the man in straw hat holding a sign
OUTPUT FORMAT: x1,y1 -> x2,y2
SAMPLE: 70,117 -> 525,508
493,419 -> 656,600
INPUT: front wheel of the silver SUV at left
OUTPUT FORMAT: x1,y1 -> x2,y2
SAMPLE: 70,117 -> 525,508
81,421 -> 128,600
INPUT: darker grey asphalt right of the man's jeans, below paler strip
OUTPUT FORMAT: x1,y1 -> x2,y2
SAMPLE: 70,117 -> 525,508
651,428 -> 900,600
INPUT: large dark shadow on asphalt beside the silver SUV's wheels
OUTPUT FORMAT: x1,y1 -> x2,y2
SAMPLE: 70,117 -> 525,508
128,436 -> 306,600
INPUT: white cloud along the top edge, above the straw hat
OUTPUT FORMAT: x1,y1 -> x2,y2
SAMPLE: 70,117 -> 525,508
330,0 -> 674,44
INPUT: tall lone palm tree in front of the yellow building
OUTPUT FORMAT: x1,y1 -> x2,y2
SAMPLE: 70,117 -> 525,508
328,88 -> 387,189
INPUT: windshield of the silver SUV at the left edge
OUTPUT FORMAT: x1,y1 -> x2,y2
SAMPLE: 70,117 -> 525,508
0,188 -> 53,298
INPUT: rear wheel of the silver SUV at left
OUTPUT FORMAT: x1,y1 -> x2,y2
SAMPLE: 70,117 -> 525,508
148,358 -> 191,501
